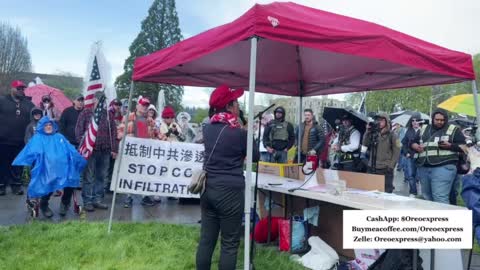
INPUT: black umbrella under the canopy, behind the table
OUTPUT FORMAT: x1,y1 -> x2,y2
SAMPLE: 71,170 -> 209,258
323,107 -> 368,134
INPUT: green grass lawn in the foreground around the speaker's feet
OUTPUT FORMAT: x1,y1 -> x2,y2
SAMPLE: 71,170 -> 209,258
0,222 -> 304,270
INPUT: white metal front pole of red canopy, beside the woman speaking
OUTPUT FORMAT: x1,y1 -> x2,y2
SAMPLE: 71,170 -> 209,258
243,37 -> 258,270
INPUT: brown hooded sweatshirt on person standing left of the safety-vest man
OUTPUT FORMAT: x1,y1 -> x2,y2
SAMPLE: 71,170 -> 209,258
362,113 -> 400,169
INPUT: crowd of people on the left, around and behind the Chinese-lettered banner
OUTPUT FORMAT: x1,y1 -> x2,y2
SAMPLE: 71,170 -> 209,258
0,81 -> 201,217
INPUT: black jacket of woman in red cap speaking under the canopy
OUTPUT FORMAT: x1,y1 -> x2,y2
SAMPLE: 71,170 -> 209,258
203,123 -> 259,188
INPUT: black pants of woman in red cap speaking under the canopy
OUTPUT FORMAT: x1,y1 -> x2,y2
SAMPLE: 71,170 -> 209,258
197,186 -> 244,270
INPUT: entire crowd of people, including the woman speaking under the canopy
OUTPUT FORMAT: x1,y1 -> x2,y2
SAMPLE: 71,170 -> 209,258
0,81 -> 468,269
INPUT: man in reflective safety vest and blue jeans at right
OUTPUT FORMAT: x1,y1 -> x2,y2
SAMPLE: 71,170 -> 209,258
410,110 -> 465,204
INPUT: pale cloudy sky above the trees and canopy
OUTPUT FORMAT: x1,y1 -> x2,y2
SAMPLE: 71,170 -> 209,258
0,0 -> 480,106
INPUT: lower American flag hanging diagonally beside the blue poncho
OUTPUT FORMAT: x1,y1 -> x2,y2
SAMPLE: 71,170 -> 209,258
78,96 -> 106,159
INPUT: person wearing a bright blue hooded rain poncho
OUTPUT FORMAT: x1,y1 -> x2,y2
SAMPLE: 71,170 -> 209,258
13,116 -> 87,217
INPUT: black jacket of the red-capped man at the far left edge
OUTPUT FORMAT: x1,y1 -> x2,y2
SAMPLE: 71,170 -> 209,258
0,95 -> 34,146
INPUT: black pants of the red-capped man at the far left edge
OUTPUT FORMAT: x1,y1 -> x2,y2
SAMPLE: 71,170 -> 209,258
0,144 -> 23,189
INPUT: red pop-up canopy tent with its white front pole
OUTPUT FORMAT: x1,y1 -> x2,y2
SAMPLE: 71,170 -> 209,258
127,3 -> 475,269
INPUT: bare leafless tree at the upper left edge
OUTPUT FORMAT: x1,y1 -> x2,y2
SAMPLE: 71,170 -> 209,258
0,22 -> 32,93
